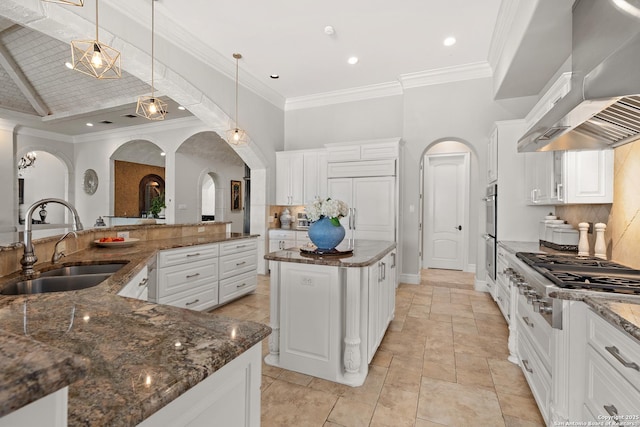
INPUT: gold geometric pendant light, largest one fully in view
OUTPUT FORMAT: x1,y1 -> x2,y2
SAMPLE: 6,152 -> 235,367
71,0 -> 122,79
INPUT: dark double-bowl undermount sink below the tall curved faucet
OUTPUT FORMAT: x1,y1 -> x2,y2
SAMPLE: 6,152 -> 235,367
0,263 -> 126,295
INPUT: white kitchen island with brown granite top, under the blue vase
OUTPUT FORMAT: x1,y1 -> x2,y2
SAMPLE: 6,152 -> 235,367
265,240 -> 397,387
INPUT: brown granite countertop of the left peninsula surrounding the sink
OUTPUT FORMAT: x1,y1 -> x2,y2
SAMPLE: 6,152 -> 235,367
0,233 -> 271,426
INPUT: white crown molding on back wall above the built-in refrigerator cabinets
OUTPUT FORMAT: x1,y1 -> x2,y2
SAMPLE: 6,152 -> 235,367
284,82 -> 402,111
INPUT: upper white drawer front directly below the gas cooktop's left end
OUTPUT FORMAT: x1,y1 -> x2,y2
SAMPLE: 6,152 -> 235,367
517,295 -> 552,372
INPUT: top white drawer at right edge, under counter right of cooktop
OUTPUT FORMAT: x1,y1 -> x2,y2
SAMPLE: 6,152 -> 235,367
587,310 -> 640,392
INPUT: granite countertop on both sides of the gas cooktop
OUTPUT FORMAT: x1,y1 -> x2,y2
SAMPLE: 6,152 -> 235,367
500,241 -> 640,341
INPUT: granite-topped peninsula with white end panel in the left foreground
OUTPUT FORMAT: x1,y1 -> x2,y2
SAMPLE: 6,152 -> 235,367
0,223 -> 270,426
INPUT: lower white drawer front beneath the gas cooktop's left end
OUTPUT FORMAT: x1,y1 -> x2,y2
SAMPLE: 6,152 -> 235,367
518,328 -> 551,423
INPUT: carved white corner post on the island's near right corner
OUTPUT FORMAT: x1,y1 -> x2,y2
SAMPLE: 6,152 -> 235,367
344,268 -> 362,378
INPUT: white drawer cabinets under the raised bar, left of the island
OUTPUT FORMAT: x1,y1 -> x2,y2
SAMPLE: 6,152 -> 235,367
149,238 -> 258,311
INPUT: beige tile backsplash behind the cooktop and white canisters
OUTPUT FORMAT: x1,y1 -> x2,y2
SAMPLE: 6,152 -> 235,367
556,141 -> 640,268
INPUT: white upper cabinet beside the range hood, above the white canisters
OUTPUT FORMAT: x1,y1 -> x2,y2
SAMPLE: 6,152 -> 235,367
525,150 -> 613,205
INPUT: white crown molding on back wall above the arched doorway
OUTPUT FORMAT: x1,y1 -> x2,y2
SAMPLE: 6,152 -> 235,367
400,62 -> 493,89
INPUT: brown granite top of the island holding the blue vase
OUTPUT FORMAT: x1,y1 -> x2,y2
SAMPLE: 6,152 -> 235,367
264,240 -> 396,267
